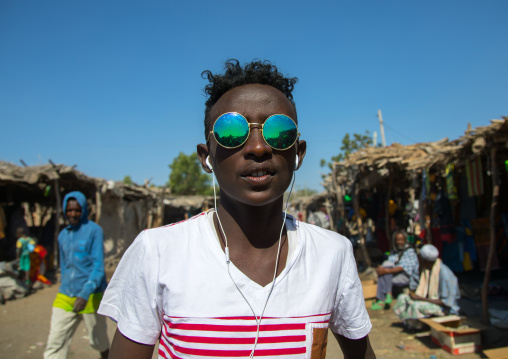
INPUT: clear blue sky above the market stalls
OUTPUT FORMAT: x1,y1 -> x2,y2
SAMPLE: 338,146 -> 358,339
0,0 -> 508,190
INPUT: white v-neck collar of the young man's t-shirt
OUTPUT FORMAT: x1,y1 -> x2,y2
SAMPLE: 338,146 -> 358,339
205,209 -> 303,293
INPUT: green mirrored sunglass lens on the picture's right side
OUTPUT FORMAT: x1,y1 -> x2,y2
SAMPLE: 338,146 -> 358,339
263,115 -> 298,150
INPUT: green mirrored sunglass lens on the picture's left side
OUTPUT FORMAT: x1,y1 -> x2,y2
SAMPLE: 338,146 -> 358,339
213,113 -> 249,148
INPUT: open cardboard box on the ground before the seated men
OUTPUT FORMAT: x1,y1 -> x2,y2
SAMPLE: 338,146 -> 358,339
420,315 -> 481,354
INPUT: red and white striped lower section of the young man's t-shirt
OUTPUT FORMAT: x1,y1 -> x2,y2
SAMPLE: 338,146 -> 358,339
159,313 -> 330,359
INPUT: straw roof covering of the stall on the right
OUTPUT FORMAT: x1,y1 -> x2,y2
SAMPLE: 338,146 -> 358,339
324,117 -> 508,190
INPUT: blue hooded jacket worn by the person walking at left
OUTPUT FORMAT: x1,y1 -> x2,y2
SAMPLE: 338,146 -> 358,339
58,191 -> 106,300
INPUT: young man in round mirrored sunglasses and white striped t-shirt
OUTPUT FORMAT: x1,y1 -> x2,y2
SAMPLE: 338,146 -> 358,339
99,60 -> 375,359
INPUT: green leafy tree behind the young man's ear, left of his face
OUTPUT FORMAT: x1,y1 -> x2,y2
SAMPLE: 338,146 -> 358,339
168,152 -> 211,195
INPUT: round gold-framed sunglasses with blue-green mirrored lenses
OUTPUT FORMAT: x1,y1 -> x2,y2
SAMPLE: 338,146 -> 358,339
207,112 -> 300,151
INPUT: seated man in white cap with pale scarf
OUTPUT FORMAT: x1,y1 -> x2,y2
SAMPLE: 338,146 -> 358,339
393,244 -> 460,328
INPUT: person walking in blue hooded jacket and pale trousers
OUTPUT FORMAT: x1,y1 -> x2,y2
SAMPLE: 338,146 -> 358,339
44,191 -> 109,359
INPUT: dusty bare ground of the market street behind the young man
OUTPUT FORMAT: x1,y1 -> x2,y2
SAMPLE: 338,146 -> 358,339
0,285 -> 481,359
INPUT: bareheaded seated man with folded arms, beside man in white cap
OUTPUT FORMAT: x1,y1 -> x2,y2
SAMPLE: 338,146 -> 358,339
371,230 -> 418,310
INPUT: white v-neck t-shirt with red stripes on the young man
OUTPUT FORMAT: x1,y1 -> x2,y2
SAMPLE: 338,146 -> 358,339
98,212 -> 372,359
